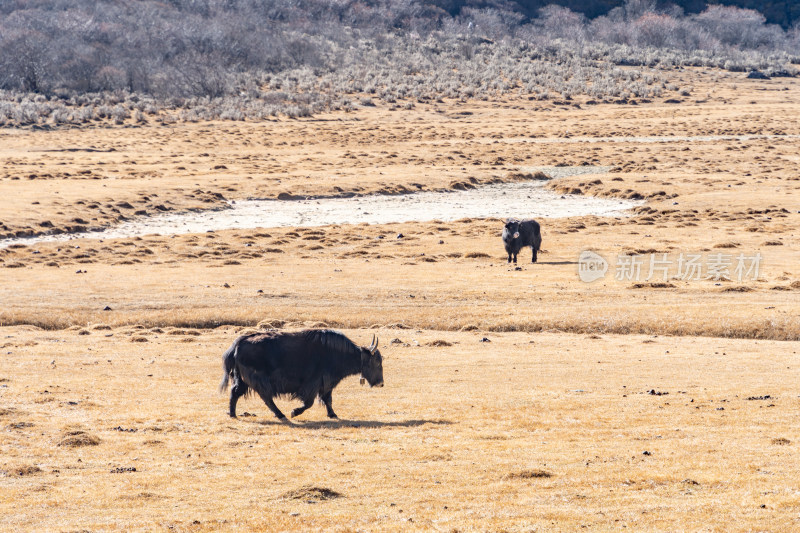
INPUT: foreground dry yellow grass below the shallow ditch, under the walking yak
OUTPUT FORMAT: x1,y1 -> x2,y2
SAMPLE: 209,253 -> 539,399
0,327 -> 800,531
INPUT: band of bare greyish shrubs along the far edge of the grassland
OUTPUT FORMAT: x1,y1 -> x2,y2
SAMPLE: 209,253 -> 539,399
0,0 -> 800,126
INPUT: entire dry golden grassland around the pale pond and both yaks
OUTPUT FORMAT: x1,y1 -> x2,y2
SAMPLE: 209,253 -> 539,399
0,70 -> 800,531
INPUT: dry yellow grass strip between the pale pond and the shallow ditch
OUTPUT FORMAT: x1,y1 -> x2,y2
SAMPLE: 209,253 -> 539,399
0,214 -> 800,340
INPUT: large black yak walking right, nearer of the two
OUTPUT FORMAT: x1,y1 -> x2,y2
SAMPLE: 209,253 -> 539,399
219,329 -> 383,419
